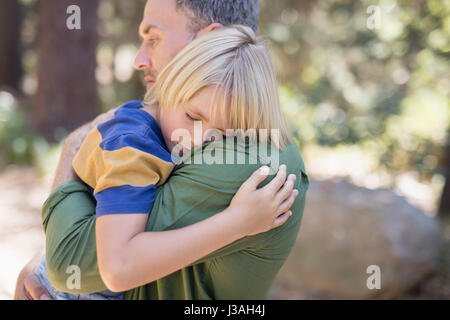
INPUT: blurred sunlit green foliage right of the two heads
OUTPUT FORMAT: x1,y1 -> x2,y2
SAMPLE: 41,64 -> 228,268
261,0 -> 450,178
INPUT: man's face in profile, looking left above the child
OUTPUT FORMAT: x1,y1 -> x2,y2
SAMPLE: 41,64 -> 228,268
134,0 -> 195,90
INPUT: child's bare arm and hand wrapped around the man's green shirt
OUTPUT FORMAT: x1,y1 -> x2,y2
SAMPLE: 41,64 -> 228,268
96,166 -> 298,291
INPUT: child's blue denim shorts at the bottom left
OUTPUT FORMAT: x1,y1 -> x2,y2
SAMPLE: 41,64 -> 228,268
34,256 -> 124,300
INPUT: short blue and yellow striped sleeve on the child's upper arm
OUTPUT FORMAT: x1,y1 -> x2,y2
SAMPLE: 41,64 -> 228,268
73,131 -> 173,217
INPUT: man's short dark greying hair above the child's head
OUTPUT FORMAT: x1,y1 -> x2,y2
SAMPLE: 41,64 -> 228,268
176,0 -> 259,33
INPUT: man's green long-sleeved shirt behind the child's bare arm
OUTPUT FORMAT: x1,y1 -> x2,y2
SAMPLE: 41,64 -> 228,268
42,142 -> 309,300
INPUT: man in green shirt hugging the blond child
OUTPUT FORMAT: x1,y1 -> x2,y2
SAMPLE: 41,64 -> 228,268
16,0 -> 308,299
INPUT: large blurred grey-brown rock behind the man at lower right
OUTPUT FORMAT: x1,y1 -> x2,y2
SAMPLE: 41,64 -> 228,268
275,179 -> 441,299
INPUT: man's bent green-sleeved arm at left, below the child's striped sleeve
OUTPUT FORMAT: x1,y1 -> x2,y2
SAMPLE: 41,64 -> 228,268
42,181 -> 107,294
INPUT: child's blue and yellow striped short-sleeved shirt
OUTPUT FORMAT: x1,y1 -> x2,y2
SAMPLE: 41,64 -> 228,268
72,101 -> 174,217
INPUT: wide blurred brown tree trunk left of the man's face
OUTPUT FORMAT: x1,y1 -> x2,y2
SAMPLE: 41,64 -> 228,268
32,0 -> 99,141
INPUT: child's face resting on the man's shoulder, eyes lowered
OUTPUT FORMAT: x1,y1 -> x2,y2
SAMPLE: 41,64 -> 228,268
159,87 -> 227,153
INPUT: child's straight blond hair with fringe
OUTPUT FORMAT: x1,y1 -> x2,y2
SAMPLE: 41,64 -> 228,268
144,25 -> 291,149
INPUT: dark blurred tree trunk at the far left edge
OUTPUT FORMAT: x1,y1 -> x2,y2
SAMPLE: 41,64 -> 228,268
0,0 -> 22,93
